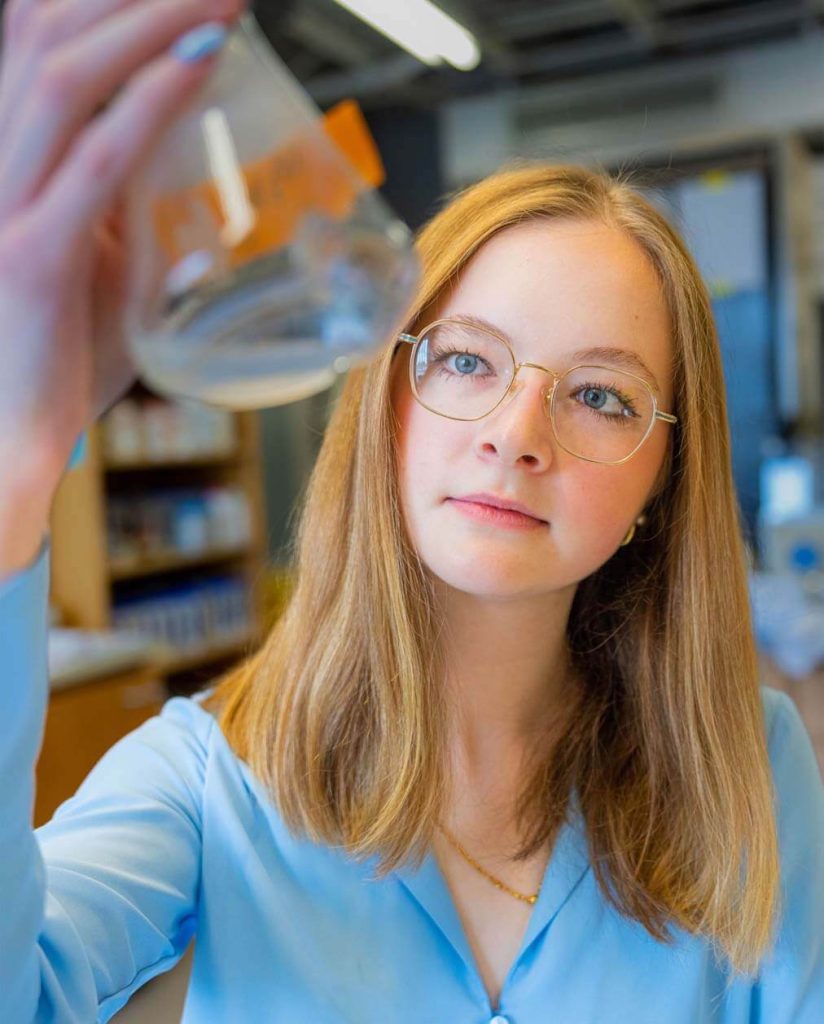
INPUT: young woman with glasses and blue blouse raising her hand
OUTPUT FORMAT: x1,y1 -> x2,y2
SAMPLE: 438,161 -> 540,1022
0,0 -> 824,1024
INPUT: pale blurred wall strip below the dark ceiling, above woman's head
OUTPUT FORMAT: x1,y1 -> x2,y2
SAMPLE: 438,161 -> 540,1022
441,32 -> 824,187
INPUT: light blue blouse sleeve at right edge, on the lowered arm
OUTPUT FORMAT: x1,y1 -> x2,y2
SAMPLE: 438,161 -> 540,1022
750,689 -> 824,1024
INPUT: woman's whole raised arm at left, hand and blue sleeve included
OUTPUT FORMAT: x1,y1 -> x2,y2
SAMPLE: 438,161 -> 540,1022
0,0 -> 243,1024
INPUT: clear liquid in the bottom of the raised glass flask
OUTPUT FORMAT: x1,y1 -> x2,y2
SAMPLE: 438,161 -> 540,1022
132,214 -> 418,410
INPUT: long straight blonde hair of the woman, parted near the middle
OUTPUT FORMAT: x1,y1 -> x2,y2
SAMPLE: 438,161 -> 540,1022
205,164 -> 779,974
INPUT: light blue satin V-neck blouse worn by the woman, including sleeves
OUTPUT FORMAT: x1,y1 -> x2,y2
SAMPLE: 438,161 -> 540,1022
0,543 -> 824,1024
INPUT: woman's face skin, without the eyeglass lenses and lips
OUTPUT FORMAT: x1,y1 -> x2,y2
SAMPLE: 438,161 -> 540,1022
392,220 -> 673,599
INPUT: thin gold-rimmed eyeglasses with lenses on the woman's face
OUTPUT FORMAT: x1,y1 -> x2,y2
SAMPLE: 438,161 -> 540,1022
398,317 -> 678,466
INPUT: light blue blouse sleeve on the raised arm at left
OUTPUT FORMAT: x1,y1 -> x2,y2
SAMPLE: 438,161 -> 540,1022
0,544 -> 212,1024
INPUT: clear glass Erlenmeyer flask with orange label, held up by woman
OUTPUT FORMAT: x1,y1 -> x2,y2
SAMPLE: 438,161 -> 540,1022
126,14 -> 419,409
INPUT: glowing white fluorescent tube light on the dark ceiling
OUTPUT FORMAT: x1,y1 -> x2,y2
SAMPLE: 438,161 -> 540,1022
337,0 -> 481,71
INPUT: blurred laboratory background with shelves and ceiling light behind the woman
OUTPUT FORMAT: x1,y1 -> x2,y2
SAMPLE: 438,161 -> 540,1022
27,0 -> 824,880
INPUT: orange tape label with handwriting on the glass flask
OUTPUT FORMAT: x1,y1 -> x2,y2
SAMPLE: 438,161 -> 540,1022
153,99 -> 385,267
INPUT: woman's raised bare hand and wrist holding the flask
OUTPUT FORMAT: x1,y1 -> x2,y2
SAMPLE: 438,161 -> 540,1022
0,0 -> 246,577
